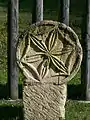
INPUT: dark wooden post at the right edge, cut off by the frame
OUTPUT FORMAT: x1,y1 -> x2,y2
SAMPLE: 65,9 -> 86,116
81,0 -> 90,100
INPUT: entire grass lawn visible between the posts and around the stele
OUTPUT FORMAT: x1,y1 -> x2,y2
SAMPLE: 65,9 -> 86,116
0,0 -> 90,120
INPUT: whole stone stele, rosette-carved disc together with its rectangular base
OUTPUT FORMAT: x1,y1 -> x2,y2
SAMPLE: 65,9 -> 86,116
16,20 -> 82,120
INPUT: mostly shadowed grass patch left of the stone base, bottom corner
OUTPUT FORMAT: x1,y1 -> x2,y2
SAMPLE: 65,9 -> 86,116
0,100 -> 23,120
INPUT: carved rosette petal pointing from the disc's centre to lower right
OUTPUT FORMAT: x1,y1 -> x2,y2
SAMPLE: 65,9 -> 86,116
51,55 -> 68,75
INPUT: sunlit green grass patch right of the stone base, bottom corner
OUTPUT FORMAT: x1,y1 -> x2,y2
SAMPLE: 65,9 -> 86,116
66,101 -> 90,120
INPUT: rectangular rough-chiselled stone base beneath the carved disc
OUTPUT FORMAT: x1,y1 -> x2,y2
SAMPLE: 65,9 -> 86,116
23,84 -> 67,120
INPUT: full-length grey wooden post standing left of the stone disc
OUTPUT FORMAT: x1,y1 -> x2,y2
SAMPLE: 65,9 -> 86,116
8,0 -> 19,99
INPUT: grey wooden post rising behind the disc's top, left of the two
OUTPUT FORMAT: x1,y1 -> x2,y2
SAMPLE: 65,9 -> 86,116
32,0 -> 43,23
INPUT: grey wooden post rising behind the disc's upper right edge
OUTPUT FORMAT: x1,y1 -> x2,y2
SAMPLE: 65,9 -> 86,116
59,0 -> 70,25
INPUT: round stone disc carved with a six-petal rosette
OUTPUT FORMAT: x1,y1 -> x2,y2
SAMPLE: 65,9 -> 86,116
17,21 -> 82,84
